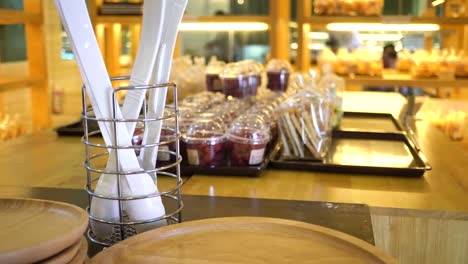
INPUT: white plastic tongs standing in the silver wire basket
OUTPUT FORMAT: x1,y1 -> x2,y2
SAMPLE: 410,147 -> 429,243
55,0 -> 186,239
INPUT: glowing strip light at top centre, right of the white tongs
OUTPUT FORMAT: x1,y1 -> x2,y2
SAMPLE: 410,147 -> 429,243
179,22 -> 268,31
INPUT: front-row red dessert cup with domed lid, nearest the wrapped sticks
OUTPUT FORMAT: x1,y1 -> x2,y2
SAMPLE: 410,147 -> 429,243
227,115 -> 270,166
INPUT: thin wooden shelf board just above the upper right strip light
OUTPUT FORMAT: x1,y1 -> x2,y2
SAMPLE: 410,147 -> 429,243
304,15 -> 468,26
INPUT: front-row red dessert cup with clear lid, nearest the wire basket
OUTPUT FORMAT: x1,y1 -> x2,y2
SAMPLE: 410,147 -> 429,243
182,119 -> 226,167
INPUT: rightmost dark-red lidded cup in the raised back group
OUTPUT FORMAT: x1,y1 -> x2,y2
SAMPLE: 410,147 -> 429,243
266,59 -> 292,92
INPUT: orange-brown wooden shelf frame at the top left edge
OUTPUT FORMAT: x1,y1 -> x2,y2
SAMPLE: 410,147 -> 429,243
0,0 -> 51,130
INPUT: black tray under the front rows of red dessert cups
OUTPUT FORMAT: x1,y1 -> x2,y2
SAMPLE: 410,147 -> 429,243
180,144 -> 280,177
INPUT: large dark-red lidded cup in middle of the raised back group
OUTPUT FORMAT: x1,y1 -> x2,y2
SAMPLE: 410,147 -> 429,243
220,63 -> 249,98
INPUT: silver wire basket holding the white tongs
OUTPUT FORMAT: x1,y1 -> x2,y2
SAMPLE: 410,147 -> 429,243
82,76 -> 183,247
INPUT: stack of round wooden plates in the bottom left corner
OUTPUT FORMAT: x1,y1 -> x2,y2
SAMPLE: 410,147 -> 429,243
0,199 -> 88,263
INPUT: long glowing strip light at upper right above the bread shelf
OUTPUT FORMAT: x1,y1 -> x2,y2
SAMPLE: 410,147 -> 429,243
327,23 -> 440,31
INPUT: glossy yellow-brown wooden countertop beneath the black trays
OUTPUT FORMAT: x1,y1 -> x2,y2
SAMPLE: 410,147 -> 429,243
0,120 -> 468,212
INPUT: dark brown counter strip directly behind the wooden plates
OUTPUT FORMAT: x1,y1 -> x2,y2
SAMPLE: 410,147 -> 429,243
0,186 -> 374,256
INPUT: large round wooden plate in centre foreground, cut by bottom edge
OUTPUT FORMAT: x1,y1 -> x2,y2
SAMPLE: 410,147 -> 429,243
91,217 -> 395,263
